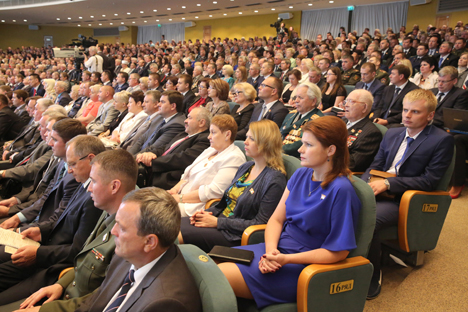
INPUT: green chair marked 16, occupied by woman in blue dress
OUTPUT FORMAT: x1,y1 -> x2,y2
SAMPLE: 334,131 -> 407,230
238,176 -> 375,312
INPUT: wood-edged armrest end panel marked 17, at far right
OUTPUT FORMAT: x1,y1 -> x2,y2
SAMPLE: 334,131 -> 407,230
398,190 -> 452,252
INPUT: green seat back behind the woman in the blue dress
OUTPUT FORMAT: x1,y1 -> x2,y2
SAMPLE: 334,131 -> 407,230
348,176 -> 376,258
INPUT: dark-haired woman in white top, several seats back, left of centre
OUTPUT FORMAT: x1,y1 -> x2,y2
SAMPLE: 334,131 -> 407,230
101,90 -> 148,146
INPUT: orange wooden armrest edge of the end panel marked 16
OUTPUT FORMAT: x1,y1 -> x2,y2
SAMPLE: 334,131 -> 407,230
297,256 -> 370,311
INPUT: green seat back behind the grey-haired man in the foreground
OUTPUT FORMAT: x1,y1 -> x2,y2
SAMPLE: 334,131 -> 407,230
178,244 -> 237,312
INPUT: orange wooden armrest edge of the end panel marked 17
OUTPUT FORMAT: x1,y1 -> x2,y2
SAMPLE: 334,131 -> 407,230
398,190 -> 450,252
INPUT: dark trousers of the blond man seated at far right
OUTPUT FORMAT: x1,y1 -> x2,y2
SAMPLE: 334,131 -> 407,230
367,201 -> 400,283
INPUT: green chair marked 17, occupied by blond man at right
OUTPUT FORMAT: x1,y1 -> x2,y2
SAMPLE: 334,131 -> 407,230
379,147 -> 455,266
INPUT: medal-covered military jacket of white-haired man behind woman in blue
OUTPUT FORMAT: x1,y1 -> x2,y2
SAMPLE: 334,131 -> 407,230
281,108 -> 323,157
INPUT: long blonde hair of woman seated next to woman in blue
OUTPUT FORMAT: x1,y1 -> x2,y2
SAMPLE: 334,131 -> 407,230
249,119 -> 286,174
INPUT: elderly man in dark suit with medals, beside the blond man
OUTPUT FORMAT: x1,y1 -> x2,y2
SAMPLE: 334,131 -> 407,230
344,89 -> 382,172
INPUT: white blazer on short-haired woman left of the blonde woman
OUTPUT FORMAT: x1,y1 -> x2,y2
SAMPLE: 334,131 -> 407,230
179,143 -> 246,216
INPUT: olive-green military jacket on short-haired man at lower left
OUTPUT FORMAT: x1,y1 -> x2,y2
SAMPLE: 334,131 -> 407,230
40,211 -> 115,312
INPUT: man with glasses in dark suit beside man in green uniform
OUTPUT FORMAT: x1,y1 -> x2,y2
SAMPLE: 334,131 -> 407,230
0,135 -> 105,305
